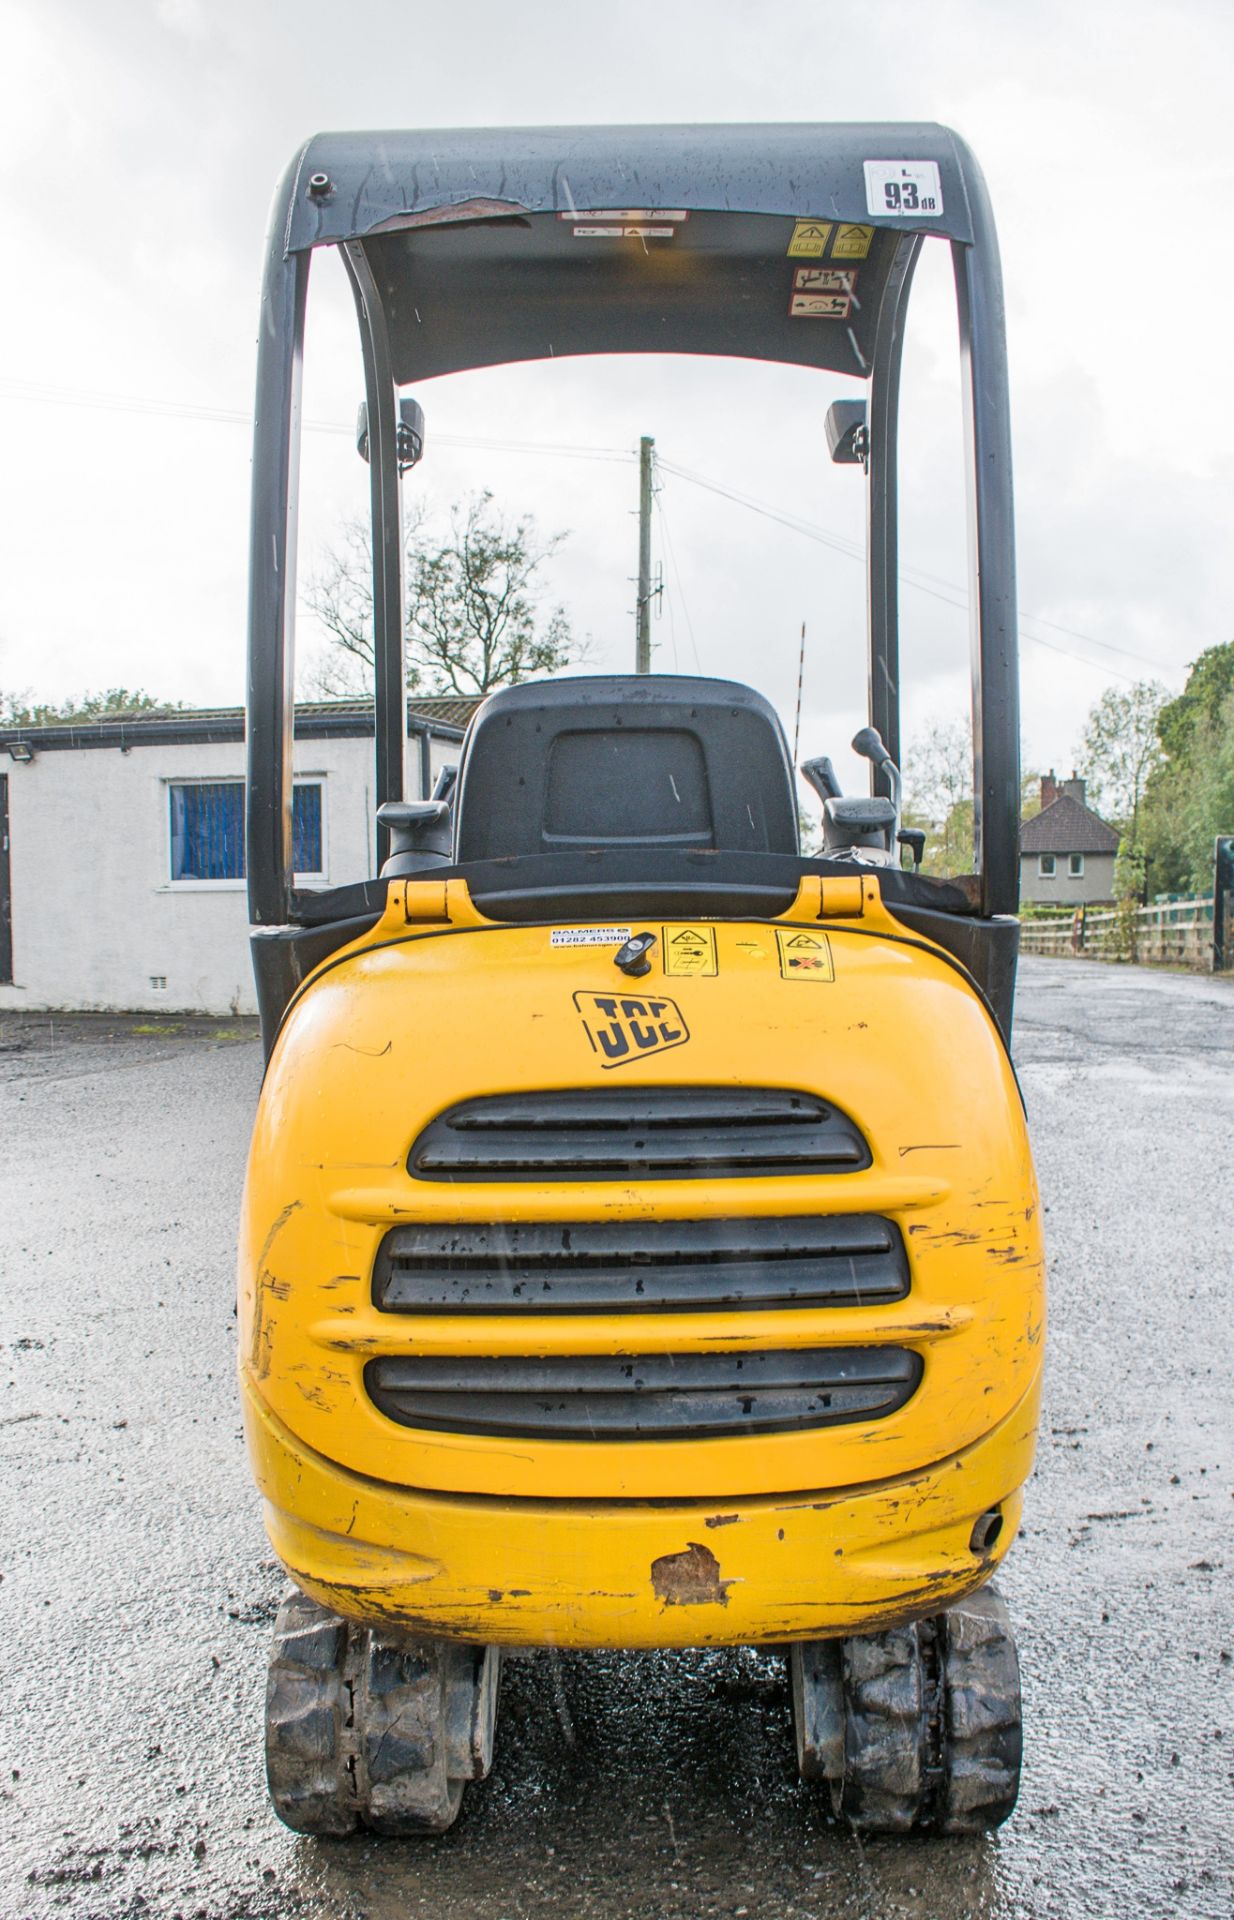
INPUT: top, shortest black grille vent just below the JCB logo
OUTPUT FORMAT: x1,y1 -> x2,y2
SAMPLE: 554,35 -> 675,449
407,1087 -> 869,1181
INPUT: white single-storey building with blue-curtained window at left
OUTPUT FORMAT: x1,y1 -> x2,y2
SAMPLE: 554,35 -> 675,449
0,699 -> 478,1014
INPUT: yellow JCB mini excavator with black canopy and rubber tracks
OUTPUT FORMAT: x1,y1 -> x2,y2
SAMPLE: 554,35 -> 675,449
240,125 -> 1044,1836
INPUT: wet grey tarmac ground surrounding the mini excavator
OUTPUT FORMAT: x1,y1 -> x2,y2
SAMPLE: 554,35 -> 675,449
0,960 -> 1234,1920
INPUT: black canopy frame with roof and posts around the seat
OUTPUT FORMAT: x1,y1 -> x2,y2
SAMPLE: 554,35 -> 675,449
248,125 -> 1019,936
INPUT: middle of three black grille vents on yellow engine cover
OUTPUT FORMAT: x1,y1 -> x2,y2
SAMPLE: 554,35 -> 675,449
372,1213 -> 908,1313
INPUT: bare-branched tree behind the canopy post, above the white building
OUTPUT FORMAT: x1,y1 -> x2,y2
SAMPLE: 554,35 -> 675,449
305,492 -> 581,697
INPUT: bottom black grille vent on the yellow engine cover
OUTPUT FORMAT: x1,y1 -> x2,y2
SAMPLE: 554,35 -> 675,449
365,1346 -> 921,1442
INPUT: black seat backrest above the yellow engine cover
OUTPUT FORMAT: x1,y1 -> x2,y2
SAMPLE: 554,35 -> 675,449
455,674 -> 798,864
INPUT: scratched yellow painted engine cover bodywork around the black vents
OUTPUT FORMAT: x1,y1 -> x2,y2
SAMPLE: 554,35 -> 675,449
240,879 -> 1044,1645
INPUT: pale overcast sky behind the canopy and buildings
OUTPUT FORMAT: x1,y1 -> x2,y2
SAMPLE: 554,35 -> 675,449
0,0 -> 1234,794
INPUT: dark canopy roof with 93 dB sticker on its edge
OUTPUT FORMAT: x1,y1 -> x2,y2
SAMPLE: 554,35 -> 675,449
284,125 -> 975,384
